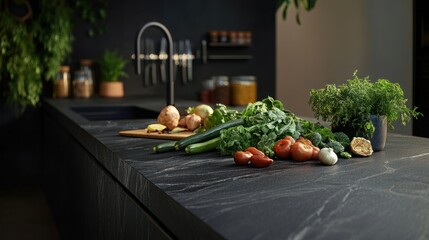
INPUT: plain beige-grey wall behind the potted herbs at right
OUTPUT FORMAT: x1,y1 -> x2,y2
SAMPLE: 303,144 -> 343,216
276,0 -> 412,134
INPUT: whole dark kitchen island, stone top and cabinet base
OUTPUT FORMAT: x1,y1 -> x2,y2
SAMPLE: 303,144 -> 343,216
44,99 -> 429,239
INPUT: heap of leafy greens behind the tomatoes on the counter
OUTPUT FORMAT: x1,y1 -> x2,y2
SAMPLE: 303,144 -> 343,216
216,97 -> 350,157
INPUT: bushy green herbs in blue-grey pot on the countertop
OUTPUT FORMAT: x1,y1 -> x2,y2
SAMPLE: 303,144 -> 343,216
309,71 -> 421,151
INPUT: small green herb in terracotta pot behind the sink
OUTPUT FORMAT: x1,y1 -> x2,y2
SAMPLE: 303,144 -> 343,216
99,50 -> 128,97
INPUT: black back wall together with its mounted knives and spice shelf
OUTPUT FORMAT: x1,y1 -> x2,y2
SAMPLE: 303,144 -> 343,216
69,0 -> 276,103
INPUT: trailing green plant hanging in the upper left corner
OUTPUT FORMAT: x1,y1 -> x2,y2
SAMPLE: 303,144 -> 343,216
0,0 -> 106,113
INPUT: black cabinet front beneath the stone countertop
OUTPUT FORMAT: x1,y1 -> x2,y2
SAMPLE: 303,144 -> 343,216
43,114 -> 171,239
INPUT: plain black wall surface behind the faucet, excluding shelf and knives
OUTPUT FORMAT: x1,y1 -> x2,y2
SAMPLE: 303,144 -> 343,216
72,0 -> 275,99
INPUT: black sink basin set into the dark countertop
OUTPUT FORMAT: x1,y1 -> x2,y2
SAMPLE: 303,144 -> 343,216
70,106 -> 159,121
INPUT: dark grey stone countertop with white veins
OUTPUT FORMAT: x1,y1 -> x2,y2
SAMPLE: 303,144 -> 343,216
44,99 -> 429,239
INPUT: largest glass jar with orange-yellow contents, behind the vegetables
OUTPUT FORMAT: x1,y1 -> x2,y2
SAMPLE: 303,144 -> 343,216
231,76 -> 257,106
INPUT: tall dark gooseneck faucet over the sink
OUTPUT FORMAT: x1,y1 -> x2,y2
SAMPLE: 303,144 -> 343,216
135,22 -> 174,105
